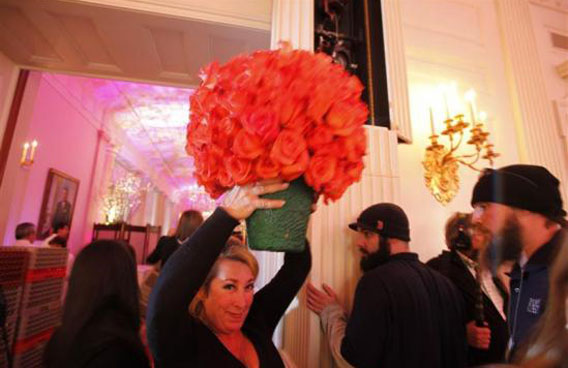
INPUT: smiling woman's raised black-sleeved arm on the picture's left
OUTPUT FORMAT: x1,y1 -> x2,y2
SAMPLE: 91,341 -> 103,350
146,209 -> 238,361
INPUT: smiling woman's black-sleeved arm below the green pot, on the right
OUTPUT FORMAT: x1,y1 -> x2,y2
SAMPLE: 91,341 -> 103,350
249,241 -> 312,334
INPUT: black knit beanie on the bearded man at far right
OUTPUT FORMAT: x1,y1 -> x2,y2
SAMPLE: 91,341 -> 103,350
471,165 -> 566,225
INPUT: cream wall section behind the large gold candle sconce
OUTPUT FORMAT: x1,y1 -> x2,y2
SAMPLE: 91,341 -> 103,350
399,0 -> 518,261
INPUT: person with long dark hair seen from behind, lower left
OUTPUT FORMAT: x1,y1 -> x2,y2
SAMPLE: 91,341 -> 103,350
44,240 -> 149,368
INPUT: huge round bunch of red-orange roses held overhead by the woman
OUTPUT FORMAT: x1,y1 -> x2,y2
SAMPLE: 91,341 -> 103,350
186,45 -> 368,250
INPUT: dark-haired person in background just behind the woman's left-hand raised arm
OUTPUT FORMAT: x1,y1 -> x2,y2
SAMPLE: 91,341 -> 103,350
146,210 -> 203,267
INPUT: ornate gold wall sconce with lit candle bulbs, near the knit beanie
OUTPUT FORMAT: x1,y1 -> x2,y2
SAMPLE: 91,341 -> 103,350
422,90 -> 499,206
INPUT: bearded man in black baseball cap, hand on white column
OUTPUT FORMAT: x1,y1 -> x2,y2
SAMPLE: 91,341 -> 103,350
307,203 -> 466,367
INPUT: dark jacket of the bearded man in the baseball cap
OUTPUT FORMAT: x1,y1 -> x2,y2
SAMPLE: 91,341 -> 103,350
341,253 -> 466,368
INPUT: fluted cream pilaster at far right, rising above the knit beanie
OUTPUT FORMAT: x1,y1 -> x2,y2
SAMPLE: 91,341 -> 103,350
495,0 -> 568,201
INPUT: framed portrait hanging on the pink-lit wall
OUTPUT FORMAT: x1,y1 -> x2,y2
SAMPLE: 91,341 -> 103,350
37,169 -> 79,239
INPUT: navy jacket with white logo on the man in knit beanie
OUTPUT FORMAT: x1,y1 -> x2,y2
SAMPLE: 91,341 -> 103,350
507,231 -> 564,358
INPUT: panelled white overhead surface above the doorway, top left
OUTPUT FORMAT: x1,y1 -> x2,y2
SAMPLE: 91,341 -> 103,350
0,0 -> 270,86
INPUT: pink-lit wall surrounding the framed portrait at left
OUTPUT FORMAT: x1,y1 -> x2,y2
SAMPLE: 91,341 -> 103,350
0,72 -> 100,253
